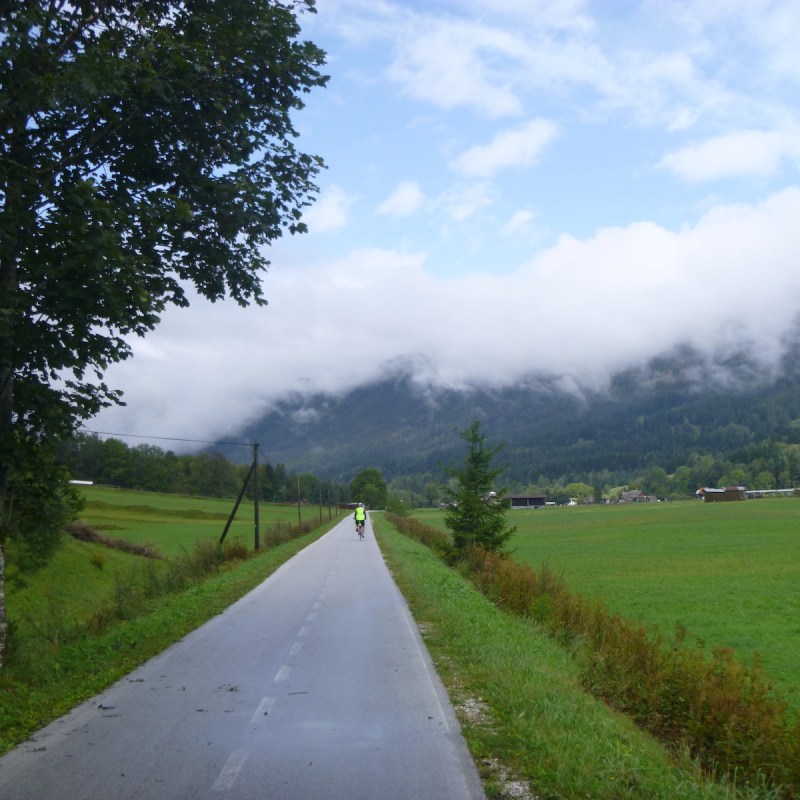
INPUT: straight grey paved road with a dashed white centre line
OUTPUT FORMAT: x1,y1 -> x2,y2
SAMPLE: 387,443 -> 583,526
0,518 -> 484,800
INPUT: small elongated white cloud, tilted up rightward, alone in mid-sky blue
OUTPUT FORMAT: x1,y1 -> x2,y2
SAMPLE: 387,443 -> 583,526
450,119 -> 558,178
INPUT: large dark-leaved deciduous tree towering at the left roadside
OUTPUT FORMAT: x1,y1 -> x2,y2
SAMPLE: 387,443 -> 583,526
0,0 -> 327,663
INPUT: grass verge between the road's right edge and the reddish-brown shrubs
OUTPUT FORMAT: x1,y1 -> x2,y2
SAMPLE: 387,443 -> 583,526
373,517 -> 774,800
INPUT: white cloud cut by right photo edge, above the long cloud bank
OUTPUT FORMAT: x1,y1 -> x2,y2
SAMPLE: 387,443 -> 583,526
661,130 -> 800,182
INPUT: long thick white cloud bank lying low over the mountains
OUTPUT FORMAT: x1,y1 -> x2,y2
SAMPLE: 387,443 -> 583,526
94,189 -> 800,438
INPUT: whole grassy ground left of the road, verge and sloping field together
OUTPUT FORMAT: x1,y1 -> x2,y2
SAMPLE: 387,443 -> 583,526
0,488 -> 337,753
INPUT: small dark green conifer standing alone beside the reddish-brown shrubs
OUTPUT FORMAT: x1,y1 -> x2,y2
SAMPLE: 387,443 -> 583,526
445,420 -> 515,553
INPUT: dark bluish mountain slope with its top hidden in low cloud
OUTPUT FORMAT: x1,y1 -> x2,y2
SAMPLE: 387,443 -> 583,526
223,348 -> 800,484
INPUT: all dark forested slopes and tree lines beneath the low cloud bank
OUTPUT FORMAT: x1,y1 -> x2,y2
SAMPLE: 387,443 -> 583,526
62,346 -> 800,506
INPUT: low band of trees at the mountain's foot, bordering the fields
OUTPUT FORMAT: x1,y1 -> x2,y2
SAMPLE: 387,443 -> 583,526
62,412 -> 800,506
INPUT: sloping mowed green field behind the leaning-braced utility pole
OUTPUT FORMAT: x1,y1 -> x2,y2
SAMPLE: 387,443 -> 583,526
80,486 -> 336,556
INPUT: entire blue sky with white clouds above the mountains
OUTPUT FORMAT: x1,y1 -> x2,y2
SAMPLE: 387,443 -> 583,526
92,0 -> 800,449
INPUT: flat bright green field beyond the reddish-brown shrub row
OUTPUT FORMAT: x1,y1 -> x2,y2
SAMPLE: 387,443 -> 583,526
415,498 -> 800,710
